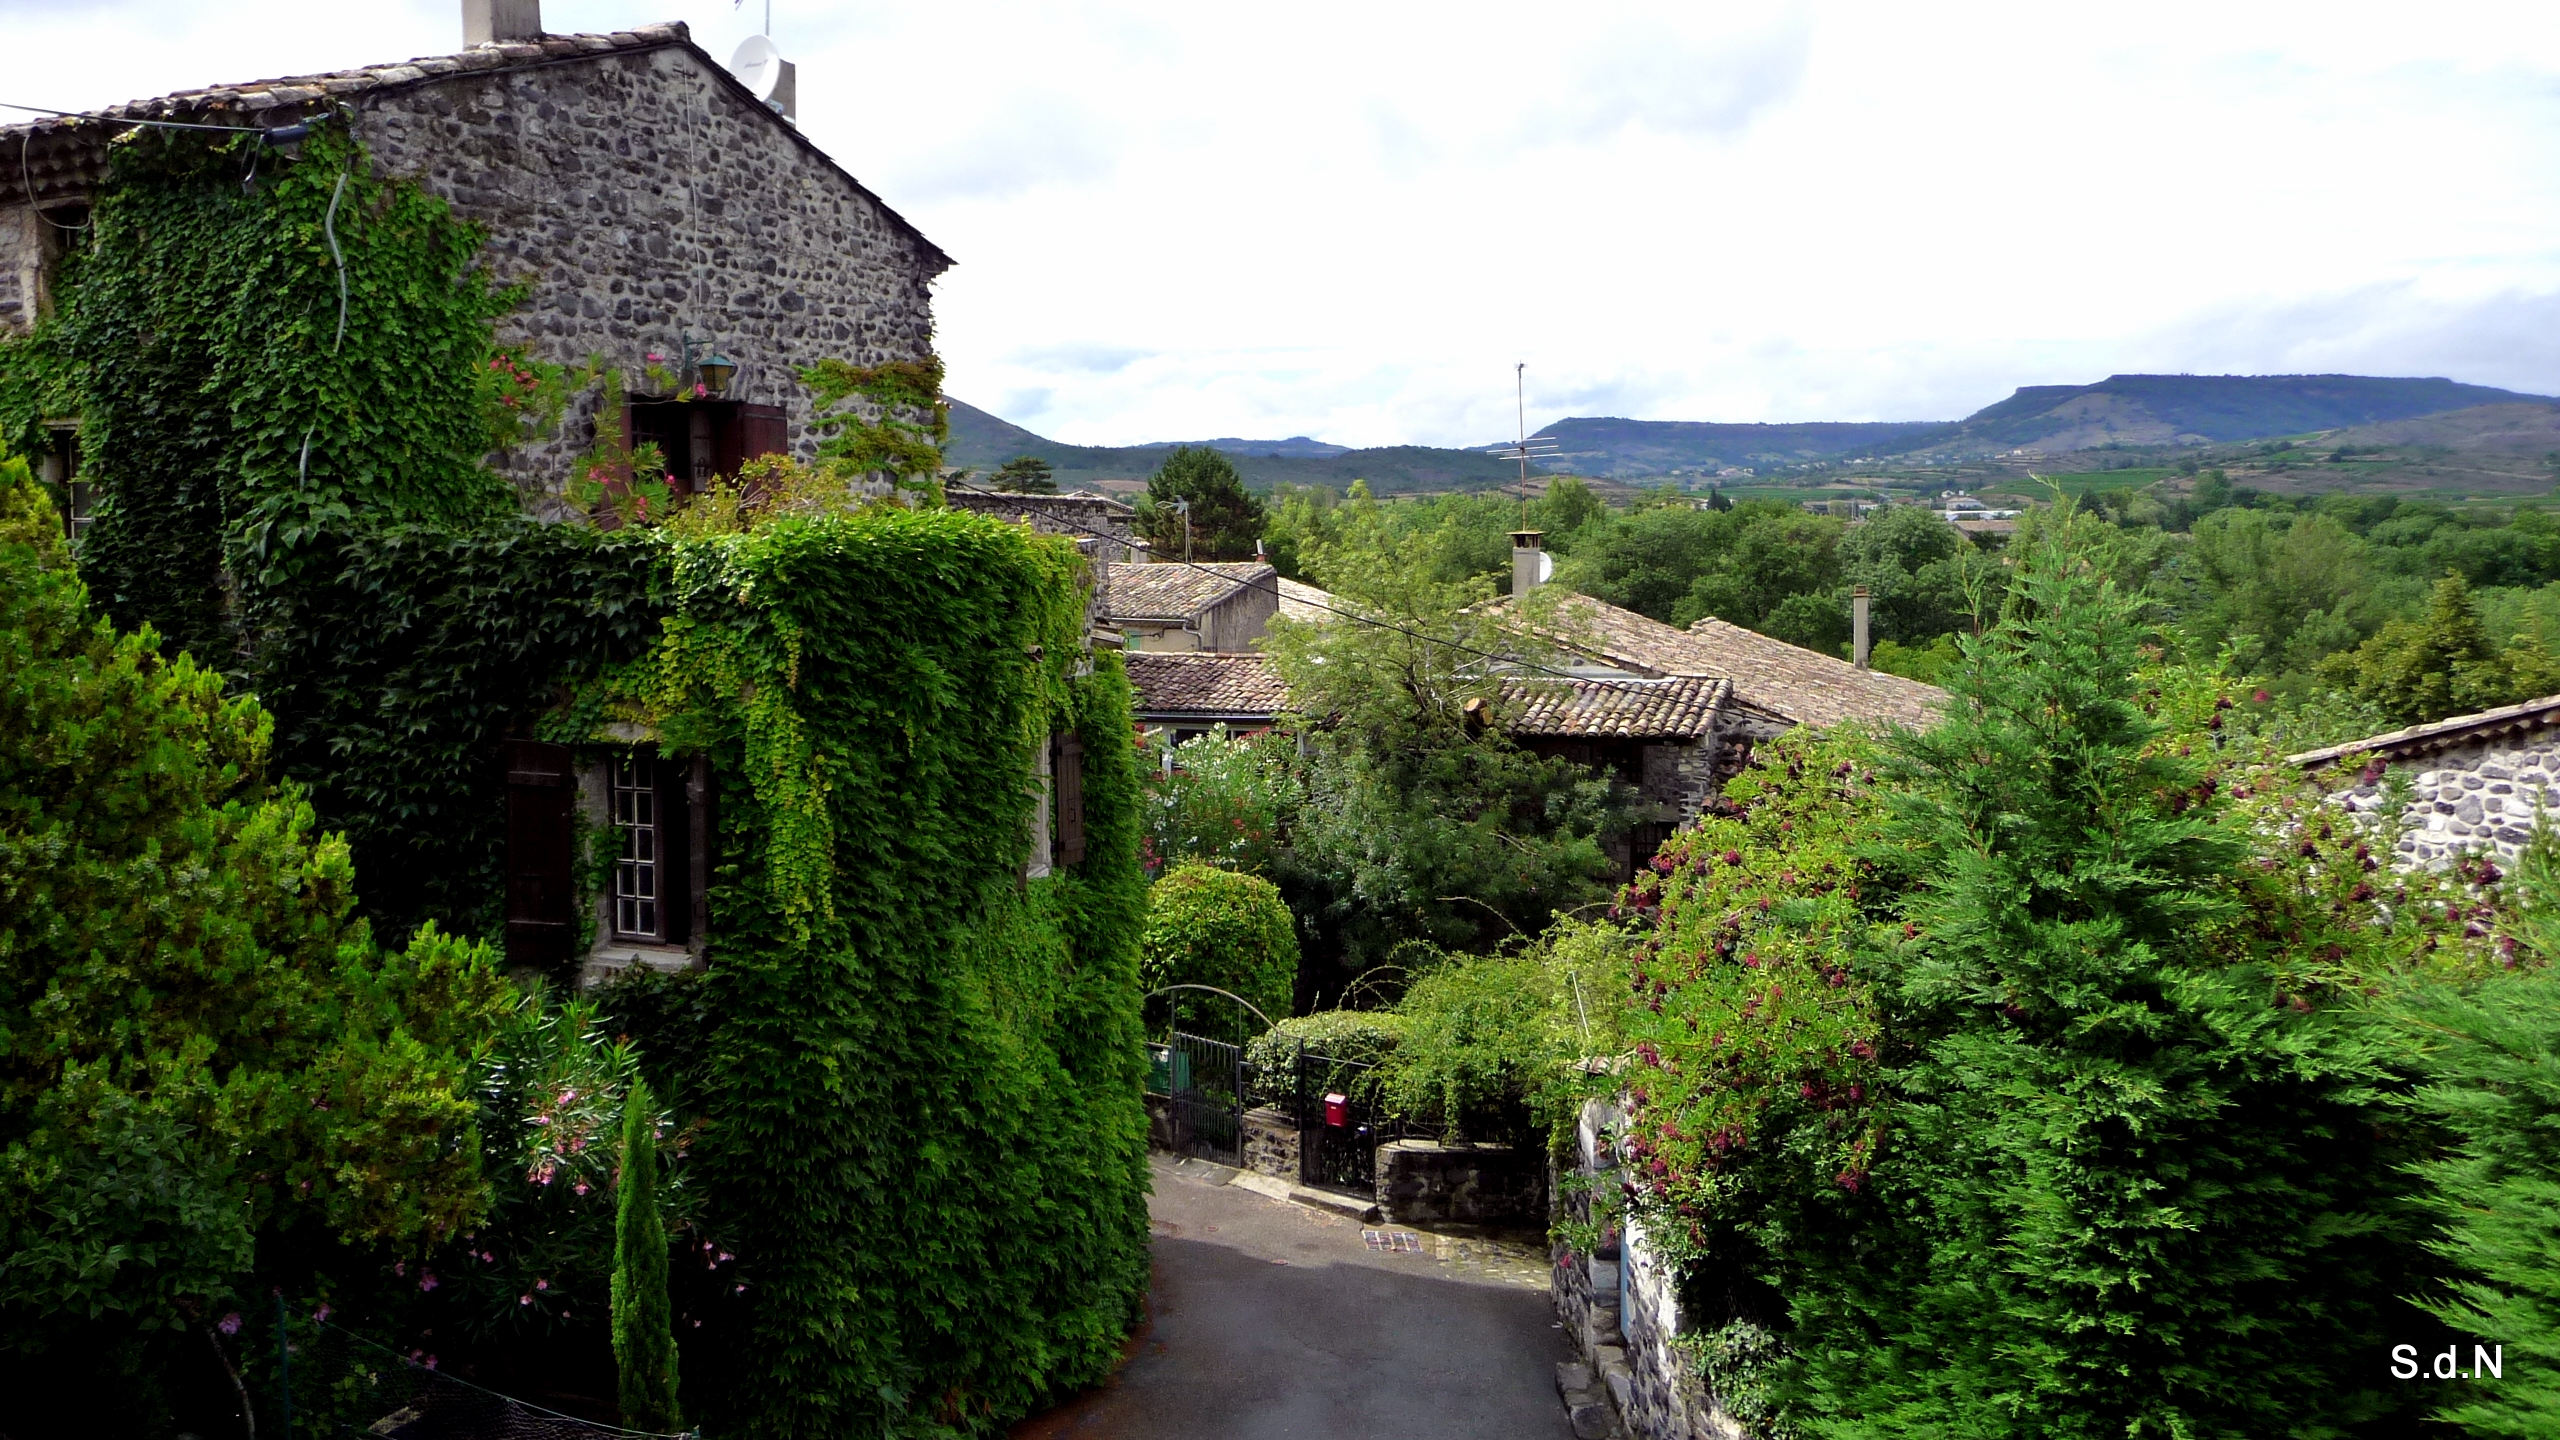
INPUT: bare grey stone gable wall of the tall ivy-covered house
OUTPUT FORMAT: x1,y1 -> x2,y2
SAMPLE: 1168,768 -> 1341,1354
361,46 -> 942,510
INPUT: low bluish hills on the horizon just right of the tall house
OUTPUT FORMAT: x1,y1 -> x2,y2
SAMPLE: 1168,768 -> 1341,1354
942,395 -> 1521,495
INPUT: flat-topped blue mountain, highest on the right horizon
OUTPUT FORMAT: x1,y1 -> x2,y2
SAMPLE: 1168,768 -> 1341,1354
1915,374 -> 2545,451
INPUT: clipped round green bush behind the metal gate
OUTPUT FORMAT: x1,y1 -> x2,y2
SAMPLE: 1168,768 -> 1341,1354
1139,861 -> 1298,1033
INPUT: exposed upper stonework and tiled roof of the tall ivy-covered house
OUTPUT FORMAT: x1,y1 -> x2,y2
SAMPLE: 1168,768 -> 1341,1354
0,0 -> 952,515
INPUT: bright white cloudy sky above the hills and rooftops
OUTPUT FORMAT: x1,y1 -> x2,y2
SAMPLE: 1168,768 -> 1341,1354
0,0 -> 2560,443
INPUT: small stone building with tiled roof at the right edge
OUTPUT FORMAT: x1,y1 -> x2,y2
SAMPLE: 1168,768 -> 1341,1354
2286,694 -> 2560,869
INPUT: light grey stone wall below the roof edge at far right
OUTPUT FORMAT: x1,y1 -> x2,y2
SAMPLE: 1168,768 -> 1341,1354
2335,728 -> 2560,869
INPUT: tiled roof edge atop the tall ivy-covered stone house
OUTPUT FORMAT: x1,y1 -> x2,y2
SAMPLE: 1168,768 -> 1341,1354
0,20 -> 950,266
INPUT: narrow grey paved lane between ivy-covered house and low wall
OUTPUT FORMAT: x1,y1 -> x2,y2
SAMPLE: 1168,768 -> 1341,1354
1014,1158 -> 1572,1440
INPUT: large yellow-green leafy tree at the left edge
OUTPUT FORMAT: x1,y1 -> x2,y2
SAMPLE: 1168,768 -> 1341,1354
0,459 -> 507,1394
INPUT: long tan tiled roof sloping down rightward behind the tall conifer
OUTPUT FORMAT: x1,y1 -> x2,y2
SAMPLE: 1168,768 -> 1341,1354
1515,594 -> 1946,725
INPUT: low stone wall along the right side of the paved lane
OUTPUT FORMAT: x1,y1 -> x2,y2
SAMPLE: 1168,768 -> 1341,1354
1554,1099 -> 1748,1440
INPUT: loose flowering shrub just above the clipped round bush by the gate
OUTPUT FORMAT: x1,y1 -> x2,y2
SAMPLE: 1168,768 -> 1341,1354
1139,728 -> 1303,876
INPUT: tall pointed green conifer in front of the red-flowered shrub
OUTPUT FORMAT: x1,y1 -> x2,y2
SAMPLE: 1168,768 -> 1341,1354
1797,515 -> 2409,1440
